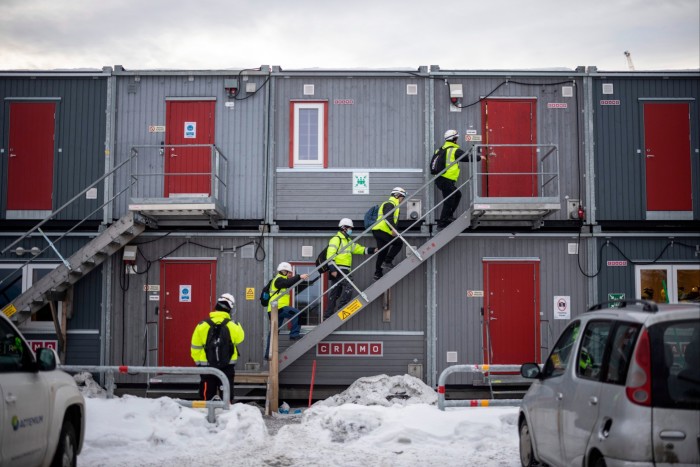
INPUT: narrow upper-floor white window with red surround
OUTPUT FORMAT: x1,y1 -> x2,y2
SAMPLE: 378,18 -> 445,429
289,101 -> 328,167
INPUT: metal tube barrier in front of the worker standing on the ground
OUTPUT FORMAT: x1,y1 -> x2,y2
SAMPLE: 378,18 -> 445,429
58,365 -> 231,423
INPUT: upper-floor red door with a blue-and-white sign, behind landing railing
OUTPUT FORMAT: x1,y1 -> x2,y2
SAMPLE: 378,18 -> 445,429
164,101 -> 215,197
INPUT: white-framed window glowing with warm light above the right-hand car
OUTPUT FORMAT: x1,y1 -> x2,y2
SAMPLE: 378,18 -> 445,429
635,264 -> 700,303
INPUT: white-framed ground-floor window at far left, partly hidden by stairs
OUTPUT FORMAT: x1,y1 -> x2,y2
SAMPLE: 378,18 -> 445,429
0,263 -> 63,332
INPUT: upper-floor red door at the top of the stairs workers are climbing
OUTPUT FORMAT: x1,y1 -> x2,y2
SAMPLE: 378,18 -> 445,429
481,99 -> 539,197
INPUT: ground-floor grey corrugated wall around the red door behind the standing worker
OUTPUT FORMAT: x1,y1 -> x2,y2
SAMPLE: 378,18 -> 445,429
108,235 -> 266,382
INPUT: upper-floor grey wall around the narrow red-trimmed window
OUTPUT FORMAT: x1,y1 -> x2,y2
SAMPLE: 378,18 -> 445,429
274,72 -> 427,220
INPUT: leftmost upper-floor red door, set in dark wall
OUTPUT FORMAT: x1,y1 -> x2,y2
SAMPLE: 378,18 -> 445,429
7,102 -> 56,211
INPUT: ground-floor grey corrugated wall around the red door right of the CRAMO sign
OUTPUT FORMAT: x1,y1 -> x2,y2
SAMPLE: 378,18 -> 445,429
436,234 -> 588,383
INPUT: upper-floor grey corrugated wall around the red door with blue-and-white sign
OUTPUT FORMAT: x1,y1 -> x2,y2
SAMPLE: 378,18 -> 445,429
110,71 -> 267,220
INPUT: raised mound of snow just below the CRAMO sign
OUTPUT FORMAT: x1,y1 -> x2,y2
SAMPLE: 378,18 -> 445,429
314,375 -> 437,407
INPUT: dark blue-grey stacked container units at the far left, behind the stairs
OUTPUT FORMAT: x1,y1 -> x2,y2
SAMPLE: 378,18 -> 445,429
0,67 -> 111,364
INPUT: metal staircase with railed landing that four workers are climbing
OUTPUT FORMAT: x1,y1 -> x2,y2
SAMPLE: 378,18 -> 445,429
278,144 -> 561,371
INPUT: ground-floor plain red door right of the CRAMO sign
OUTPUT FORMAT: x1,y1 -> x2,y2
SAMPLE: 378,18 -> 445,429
484,260 -> 540,365
